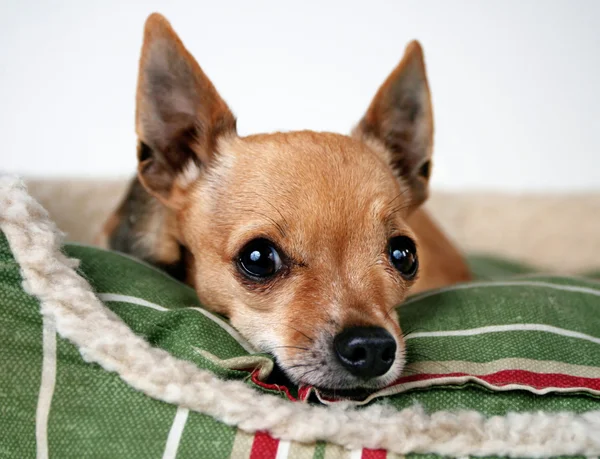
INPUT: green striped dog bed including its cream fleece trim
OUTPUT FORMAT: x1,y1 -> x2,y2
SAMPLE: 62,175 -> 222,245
0,180 -> 600,458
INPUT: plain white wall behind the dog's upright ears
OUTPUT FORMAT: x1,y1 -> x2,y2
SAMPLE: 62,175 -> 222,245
0,0 -> 600,191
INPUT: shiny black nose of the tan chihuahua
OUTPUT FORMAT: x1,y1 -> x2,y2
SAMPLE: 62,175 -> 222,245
333,327 -> 396,378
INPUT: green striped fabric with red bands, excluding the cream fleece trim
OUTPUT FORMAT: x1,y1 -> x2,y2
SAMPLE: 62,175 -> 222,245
0,235 -> 600,459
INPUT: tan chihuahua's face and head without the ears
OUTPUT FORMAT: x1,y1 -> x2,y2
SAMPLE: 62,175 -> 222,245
180,132 -> 418,388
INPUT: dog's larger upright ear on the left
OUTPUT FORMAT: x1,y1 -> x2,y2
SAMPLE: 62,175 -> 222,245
136,13 -> 236,208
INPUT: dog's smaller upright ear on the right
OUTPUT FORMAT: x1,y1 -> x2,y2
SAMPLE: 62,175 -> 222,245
355,41 -> 433,207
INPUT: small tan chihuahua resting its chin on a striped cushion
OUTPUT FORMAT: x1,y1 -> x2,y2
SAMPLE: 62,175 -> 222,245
103,14 -> 469,390
